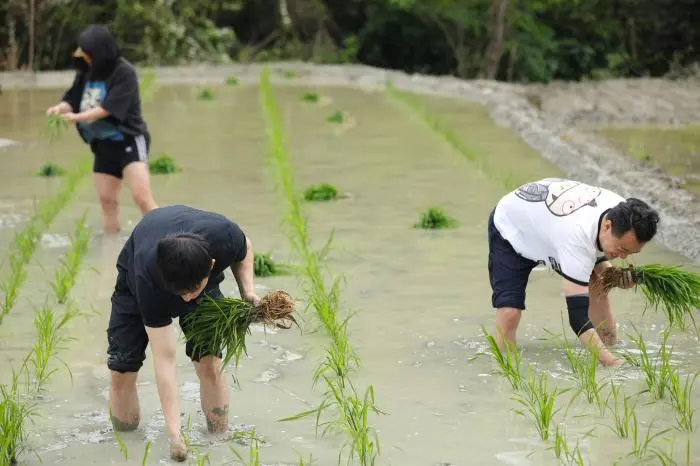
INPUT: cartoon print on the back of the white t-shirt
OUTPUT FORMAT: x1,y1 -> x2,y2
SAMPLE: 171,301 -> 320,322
515,178 -> 601,217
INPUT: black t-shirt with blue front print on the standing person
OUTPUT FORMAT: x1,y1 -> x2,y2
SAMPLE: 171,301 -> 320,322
62,57 -> 148,143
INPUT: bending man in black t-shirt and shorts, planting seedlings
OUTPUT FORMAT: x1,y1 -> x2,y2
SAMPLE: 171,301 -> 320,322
107,205 -> 259,461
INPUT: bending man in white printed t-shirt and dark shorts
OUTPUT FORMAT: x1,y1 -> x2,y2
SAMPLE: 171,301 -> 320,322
488,178 -> 659,367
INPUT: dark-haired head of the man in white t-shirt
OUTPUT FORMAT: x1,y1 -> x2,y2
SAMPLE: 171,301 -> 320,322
598,197 -> 659,259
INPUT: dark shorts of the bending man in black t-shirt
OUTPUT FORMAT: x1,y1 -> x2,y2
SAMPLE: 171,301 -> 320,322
107,285 -> 223,372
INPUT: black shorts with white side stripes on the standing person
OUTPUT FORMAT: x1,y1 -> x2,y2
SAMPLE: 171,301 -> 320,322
90,133 -> 151,179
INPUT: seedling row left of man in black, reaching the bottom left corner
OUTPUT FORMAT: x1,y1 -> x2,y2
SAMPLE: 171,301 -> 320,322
0,213 -> 89,466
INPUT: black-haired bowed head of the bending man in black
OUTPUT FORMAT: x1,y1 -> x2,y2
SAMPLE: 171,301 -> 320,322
156,232 -> 212,294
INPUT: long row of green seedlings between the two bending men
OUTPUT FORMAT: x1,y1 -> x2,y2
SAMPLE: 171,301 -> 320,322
260,69 -> 380,466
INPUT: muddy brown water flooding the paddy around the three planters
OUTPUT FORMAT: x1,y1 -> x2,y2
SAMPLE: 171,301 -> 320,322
0,82 -> 700,466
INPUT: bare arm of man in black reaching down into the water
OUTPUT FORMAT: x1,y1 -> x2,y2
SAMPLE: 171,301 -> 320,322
146,323 -> 180,440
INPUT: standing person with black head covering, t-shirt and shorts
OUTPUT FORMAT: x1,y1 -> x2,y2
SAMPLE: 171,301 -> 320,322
46,25 -> 157,233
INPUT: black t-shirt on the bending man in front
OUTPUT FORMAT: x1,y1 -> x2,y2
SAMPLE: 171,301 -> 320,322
117,205 -> 247,327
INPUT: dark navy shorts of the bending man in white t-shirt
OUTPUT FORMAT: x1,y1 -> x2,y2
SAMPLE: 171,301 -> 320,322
488,211 -> 537,310
